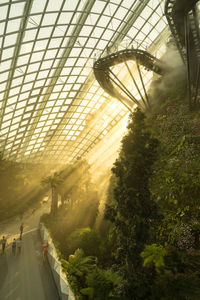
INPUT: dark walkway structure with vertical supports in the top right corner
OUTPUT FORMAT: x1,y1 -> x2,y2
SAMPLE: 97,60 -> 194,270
165,0 -> 200,109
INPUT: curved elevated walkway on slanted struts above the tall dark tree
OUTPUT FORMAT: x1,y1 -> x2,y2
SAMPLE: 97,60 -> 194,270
93,49 -> 171,110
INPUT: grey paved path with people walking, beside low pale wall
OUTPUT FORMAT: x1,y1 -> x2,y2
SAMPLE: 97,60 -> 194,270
0,203 -> 59,300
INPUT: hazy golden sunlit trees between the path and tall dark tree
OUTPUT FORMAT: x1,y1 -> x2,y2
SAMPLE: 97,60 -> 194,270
43,161 -> 99,257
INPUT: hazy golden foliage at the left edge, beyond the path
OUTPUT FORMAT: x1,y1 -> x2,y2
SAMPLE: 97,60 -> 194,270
0,154 -> 47,220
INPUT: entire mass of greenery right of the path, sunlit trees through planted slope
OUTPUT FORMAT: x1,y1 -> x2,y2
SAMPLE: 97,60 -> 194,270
43,67 -> 200,300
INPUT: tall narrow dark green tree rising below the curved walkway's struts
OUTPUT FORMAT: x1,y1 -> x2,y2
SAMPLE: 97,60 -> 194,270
105,110 -> 158,299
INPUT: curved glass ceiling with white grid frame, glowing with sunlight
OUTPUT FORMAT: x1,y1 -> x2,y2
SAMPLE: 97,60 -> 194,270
0,0 -> 169,163
